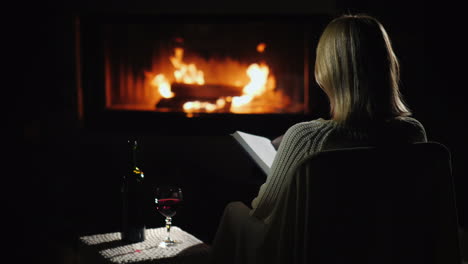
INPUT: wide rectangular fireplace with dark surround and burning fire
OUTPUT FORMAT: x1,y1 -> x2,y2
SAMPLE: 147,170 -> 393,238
77,14 -> 327,134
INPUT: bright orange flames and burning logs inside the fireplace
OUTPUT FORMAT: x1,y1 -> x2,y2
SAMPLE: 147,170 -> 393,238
146,43 -> 290,116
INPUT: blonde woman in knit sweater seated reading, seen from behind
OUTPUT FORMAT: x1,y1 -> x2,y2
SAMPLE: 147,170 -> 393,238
213,15 -> 427,264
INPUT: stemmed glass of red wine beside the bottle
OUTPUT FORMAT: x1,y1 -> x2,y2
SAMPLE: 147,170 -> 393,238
154,186 -> 183,247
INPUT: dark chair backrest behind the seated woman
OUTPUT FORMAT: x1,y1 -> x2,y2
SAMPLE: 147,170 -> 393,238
266,142 -> 461,264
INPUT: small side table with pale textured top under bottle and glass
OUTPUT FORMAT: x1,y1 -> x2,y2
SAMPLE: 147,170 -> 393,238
78,226 -> 210,264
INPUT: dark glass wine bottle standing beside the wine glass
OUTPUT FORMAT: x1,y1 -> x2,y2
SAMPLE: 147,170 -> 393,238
121,139 -> 145,243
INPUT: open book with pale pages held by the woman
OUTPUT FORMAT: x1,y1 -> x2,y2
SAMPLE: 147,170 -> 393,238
231,131 -> 276,175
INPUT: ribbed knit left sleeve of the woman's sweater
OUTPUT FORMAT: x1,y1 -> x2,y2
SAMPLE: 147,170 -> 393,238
251,121 -> 328,220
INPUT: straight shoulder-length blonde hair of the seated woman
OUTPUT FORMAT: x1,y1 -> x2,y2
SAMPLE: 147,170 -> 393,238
315,15 -> 411,123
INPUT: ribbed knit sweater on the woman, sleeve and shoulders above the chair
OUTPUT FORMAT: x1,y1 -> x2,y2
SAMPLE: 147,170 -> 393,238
251,117 -> 427,222
